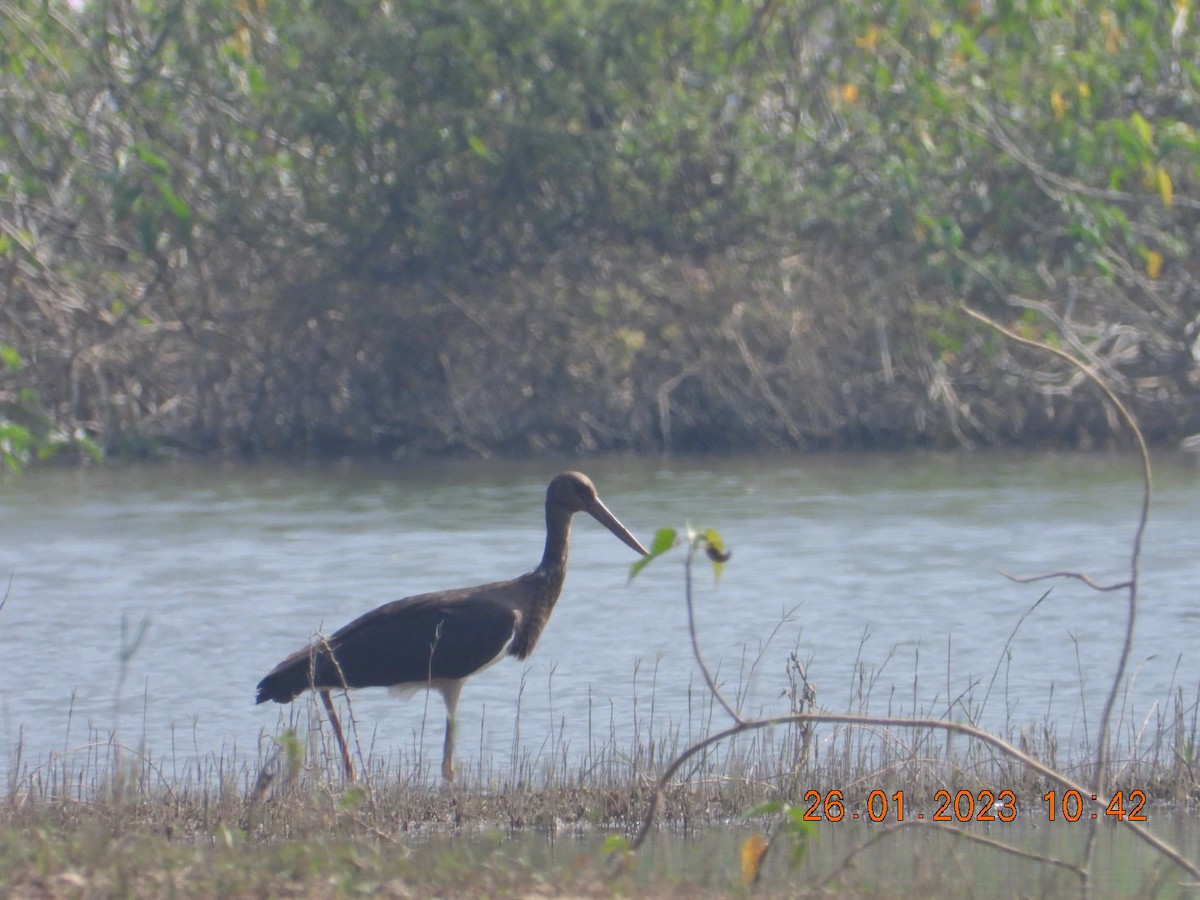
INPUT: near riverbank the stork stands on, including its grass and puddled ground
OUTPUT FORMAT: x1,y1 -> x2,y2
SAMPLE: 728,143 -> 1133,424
0,705 -> 1200,900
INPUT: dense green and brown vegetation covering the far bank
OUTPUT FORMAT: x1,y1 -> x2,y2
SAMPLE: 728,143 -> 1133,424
0,0 -> 1200,463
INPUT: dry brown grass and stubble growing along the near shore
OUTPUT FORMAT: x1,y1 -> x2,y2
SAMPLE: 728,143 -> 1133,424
0,654 -> 1200,898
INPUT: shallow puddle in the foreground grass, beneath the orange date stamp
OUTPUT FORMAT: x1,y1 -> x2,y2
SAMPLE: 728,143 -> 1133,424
628,811 -> 1200,898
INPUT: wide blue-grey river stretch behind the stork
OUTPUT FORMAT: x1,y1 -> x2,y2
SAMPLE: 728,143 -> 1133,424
0,455 -> 1200,787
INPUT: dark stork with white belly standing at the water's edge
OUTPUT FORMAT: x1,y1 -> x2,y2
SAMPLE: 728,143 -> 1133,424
256,472 -> 648,781
